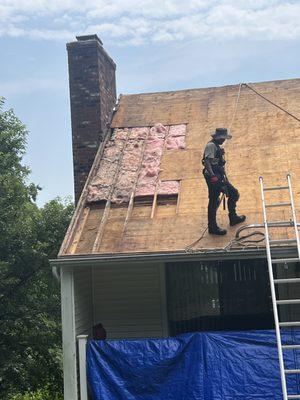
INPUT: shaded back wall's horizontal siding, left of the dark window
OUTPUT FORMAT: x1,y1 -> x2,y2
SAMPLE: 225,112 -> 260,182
93,264 -> 167,339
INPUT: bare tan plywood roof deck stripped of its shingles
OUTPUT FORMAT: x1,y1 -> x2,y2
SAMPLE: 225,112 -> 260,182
60,79 -> 300,256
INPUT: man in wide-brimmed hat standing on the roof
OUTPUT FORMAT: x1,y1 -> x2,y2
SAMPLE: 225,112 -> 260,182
202,128 -> 246,235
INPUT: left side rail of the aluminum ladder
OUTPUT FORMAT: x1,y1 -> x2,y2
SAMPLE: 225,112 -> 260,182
259,176 -> 288,400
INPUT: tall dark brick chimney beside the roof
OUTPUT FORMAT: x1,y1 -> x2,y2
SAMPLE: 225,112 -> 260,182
67,35 -> 116,203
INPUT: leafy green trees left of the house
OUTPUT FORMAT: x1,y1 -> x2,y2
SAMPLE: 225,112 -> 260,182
0,99 -> 73,398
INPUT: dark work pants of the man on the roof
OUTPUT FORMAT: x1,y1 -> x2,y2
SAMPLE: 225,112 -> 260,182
204,175 -> 240,228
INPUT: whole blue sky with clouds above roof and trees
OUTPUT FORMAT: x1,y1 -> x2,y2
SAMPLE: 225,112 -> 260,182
0,0 -> 300,205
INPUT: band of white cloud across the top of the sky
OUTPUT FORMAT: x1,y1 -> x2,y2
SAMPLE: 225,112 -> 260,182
0,0 -> 300,44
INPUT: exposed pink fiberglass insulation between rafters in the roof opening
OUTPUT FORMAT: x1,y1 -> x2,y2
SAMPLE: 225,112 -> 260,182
87,123 -> 186,204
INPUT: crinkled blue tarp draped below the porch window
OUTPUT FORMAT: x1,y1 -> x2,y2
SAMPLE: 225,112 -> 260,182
87,331 -> 300,400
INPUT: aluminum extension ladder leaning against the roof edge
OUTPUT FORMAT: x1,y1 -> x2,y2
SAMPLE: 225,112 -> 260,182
259,174 -> 300,400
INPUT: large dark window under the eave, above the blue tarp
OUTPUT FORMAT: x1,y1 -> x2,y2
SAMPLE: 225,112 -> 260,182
166,260 -> 273,335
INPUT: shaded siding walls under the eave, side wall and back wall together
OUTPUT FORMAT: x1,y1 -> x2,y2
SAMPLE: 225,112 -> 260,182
74,264 -> 168,339
